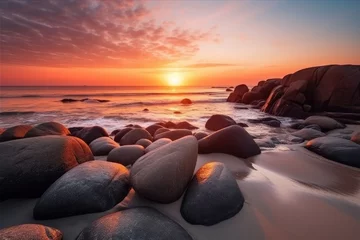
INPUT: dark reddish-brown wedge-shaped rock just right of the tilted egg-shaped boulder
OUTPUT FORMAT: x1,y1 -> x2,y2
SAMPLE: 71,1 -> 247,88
199,125 -> 260,158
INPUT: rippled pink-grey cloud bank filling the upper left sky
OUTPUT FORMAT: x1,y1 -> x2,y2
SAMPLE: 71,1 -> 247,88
0,0 -> 218,68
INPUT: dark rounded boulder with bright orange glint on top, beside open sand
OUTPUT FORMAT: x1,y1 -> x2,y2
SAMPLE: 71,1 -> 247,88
180,162 -> 244,226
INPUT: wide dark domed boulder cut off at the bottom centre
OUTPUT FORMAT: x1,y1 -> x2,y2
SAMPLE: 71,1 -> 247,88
77,207 -> 192,240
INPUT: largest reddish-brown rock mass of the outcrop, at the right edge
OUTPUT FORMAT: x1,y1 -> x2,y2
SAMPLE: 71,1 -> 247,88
262,65 -> 360,118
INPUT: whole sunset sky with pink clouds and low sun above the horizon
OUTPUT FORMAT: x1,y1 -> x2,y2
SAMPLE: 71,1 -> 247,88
0,0 -> 360,86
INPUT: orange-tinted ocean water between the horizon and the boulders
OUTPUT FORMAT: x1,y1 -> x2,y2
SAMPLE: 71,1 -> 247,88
0,86 -> 291,140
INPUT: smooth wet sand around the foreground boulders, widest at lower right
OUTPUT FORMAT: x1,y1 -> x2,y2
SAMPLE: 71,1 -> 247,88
0,145 -> 360,240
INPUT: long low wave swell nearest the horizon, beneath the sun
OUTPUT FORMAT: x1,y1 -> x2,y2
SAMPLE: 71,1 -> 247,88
0,92 -> 226,98
